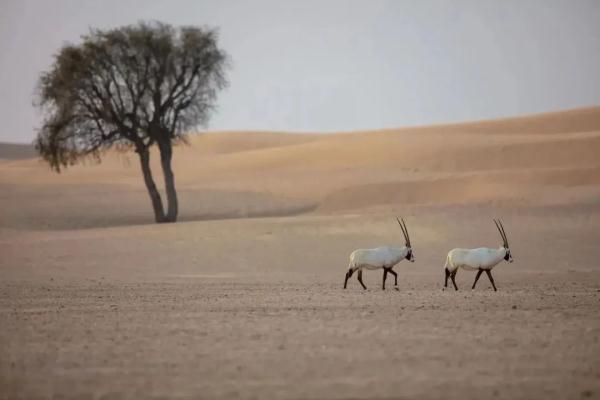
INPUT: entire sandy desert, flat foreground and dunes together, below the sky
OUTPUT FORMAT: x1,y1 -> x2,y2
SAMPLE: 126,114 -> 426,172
0,107 -> 600,399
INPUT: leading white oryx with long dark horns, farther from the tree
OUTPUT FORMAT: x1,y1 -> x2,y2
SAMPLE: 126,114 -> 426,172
444,220 -> 513,291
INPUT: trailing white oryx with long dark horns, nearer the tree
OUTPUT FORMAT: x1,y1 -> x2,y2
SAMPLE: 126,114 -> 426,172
344,218 -> 415,290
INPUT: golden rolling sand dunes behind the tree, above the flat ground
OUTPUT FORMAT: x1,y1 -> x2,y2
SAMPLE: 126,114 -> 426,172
0,107 -> 600,226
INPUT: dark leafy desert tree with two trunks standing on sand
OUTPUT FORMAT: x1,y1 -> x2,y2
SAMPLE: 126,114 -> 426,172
35,22 -> 228,222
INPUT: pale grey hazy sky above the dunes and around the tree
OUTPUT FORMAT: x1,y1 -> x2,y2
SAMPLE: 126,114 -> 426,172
0,0 -> 600,142
